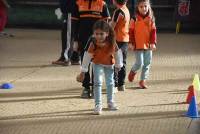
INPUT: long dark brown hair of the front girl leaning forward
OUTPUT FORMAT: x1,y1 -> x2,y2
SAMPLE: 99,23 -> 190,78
93,20 -> 116,45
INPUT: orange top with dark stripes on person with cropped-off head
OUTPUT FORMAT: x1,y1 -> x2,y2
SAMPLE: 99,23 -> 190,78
76,0 -> 105,18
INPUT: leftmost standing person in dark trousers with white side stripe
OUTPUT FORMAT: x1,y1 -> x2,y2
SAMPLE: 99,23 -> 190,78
52,0 -> 79,66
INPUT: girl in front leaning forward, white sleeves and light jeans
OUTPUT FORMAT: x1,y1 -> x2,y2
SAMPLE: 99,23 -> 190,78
77,20 -> 123,115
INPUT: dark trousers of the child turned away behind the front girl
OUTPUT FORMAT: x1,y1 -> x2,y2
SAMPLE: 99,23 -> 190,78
114,42 -> 128,87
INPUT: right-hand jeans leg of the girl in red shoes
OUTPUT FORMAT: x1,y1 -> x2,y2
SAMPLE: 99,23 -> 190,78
141,50 -> 152,80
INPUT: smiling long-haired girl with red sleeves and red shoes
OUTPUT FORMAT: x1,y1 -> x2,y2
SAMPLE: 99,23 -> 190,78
128,0 -> 156,89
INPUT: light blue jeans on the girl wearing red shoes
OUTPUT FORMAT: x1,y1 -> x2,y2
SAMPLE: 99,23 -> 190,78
131,50 -> 152,80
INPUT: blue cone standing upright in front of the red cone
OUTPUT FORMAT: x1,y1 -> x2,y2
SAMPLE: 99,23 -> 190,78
186,96 -> 199,118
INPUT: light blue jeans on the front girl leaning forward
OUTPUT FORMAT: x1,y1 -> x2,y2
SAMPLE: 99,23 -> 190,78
93,63 -> 114,106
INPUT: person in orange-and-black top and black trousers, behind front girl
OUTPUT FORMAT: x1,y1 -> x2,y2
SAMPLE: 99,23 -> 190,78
72,0 -> 110,98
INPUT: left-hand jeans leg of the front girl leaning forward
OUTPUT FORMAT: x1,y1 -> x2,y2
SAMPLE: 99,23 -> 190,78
93,64 -> 104,107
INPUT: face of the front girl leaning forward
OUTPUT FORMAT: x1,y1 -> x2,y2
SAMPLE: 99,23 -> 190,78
94,29 -> 108,43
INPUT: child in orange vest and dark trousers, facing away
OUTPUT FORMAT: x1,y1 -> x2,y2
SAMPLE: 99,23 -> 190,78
111,0 -> 130,91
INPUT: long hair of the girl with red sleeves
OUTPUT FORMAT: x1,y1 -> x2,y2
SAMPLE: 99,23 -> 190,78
135,0 -> 155,22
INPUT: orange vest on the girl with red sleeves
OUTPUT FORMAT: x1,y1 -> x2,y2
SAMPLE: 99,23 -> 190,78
130,15 -> 155,49
